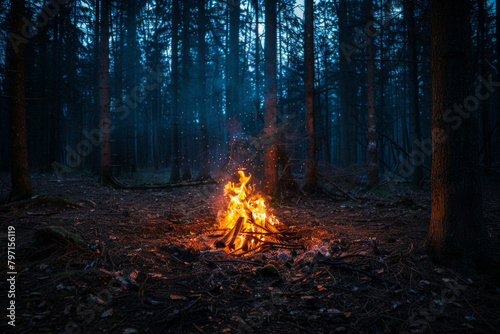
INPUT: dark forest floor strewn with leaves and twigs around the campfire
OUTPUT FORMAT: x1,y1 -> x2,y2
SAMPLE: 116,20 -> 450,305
0,172 -> 500,334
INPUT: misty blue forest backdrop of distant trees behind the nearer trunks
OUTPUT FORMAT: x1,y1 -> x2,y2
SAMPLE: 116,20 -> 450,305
0,0 -> 500,183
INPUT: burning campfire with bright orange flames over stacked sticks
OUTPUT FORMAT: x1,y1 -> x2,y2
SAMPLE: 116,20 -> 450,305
215,171 -> 281,254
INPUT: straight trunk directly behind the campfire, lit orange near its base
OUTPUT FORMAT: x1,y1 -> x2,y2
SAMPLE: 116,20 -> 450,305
264,0 -> 278,196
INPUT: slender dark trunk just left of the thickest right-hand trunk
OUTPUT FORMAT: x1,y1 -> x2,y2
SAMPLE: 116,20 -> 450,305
404,0 -> 424,184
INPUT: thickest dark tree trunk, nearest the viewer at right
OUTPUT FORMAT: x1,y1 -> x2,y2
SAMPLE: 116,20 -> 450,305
426,0 -> 487,265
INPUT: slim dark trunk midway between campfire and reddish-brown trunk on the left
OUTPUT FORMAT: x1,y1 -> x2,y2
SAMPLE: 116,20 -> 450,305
170,0 -> 181,182
